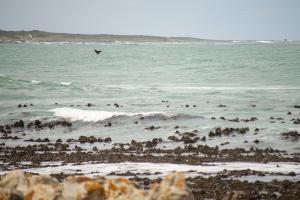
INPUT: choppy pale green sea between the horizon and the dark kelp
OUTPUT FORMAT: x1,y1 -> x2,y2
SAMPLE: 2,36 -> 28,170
0,42 -> 300,152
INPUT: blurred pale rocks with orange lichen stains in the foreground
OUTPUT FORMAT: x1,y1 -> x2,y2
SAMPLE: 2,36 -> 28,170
0,171 -> 192,200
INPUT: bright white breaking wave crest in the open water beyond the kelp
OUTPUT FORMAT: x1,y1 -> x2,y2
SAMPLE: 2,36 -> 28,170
50,107 -> 161,122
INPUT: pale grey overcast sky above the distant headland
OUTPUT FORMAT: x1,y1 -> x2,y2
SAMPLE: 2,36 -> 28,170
0,0 -> 300,40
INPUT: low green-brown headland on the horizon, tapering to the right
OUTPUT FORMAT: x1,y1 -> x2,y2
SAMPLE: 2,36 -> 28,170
0,30 -> 204,42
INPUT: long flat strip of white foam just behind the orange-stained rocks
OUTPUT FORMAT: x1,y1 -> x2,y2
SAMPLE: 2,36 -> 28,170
0,162 -> 300,179
